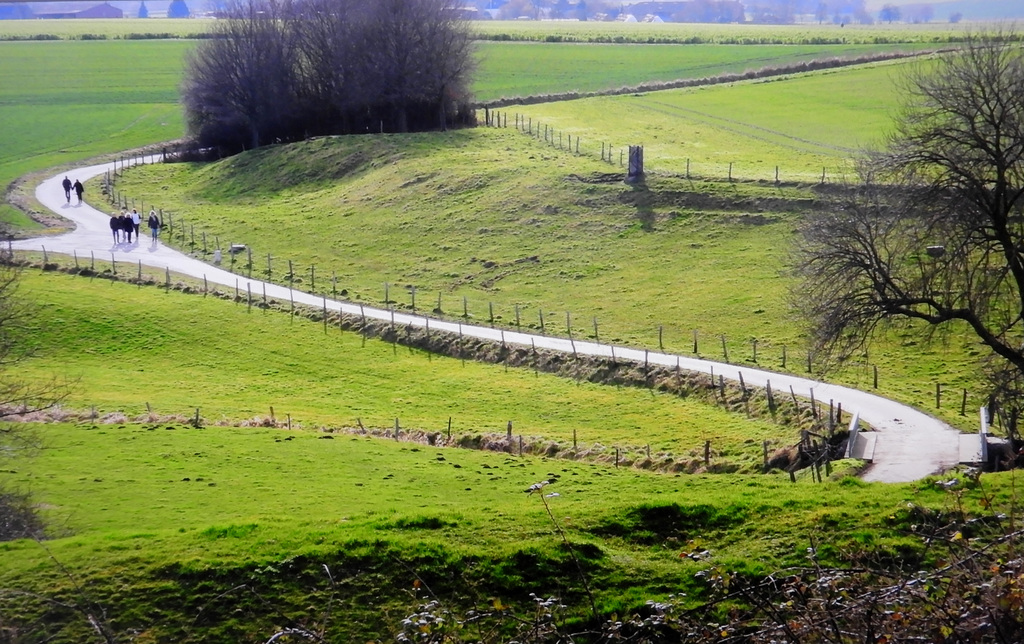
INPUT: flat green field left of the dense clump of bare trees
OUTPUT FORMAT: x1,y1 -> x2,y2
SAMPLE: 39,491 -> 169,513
0,41 -> 191,225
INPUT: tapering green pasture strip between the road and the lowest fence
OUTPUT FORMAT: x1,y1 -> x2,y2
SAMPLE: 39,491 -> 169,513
14,271 -> 794,468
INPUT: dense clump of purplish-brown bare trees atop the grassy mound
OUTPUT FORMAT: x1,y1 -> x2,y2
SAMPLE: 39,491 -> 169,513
182,0 -> 473,152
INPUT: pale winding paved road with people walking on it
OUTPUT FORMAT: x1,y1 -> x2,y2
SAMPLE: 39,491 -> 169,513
13,164 -> 959,482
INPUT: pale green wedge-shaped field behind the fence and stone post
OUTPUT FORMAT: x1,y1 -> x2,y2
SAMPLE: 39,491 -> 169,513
508,57 -> 916,178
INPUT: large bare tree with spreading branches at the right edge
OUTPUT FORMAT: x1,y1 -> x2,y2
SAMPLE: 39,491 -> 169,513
794,33 -> 1024,387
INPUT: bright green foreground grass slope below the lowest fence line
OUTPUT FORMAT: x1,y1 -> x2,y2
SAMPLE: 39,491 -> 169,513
0,409 -> 1011,642
